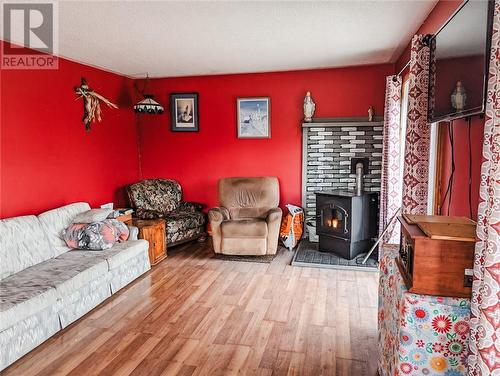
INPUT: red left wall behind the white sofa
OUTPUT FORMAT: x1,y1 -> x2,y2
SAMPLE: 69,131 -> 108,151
0,41 -> 138,218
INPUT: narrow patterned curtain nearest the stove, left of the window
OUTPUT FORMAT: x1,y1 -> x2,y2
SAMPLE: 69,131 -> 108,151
379,76 -> 401,244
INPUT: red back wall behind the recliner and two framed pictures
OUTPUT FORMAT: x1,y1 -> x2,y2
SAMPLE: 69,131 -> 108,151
139,64 -> 393,210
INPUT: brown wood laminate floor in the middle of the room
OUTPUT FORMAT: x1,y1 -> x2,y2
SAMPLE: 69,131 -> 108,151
3,242 -> 378,376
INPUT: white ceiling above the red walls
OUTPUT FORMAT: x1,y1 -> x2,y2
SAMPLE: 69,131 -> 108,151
2,0 -> 436,77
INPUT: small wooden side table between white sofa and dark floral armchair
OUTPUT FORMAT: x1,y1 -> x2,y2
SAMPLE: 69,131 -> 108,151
129,218 -> 167,265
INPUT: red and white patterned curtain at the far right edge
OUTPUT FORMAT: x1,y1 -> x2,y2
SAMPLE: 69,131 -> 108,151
468,0 -> 500,376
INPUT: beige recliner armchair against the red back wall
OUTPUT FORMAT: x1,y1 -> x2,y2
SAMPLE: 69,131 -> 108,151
208,177 -> 282,255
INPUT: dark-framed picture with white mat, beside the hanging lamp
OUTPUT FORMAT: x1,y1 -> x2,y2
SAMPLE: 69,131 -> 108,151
170,93 -> 200,132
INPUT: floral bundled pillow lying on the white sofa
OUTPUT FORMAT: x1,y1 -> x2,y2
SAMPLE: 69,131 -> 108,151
63,219 -> 129,251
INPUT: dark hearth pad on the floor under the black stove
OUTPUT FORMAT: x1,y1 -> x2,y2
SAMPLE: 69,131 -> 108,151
292,239 -> 378,271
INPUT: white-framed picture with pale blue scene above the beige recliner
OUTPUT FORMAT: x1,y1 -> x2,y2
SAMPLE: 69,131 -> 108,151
236,97 -> 271,138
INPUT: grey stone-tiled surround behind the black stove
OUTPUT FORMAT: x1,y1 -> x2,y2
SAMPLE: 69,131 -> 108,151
302,117 -> 383,218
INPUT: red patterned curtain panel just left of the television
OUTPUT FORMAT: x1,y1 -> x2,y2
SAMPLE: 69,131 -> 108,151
403,35 -> 430,214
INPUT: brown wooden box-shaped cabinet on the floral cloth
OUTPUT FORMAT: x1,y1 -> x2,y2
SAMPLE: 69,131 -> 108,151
397,216 -> 475,297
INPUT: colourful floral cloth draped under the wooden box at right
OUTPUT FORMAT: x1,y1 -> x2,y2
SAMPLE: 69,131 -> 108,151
378,248 -> 470,376
